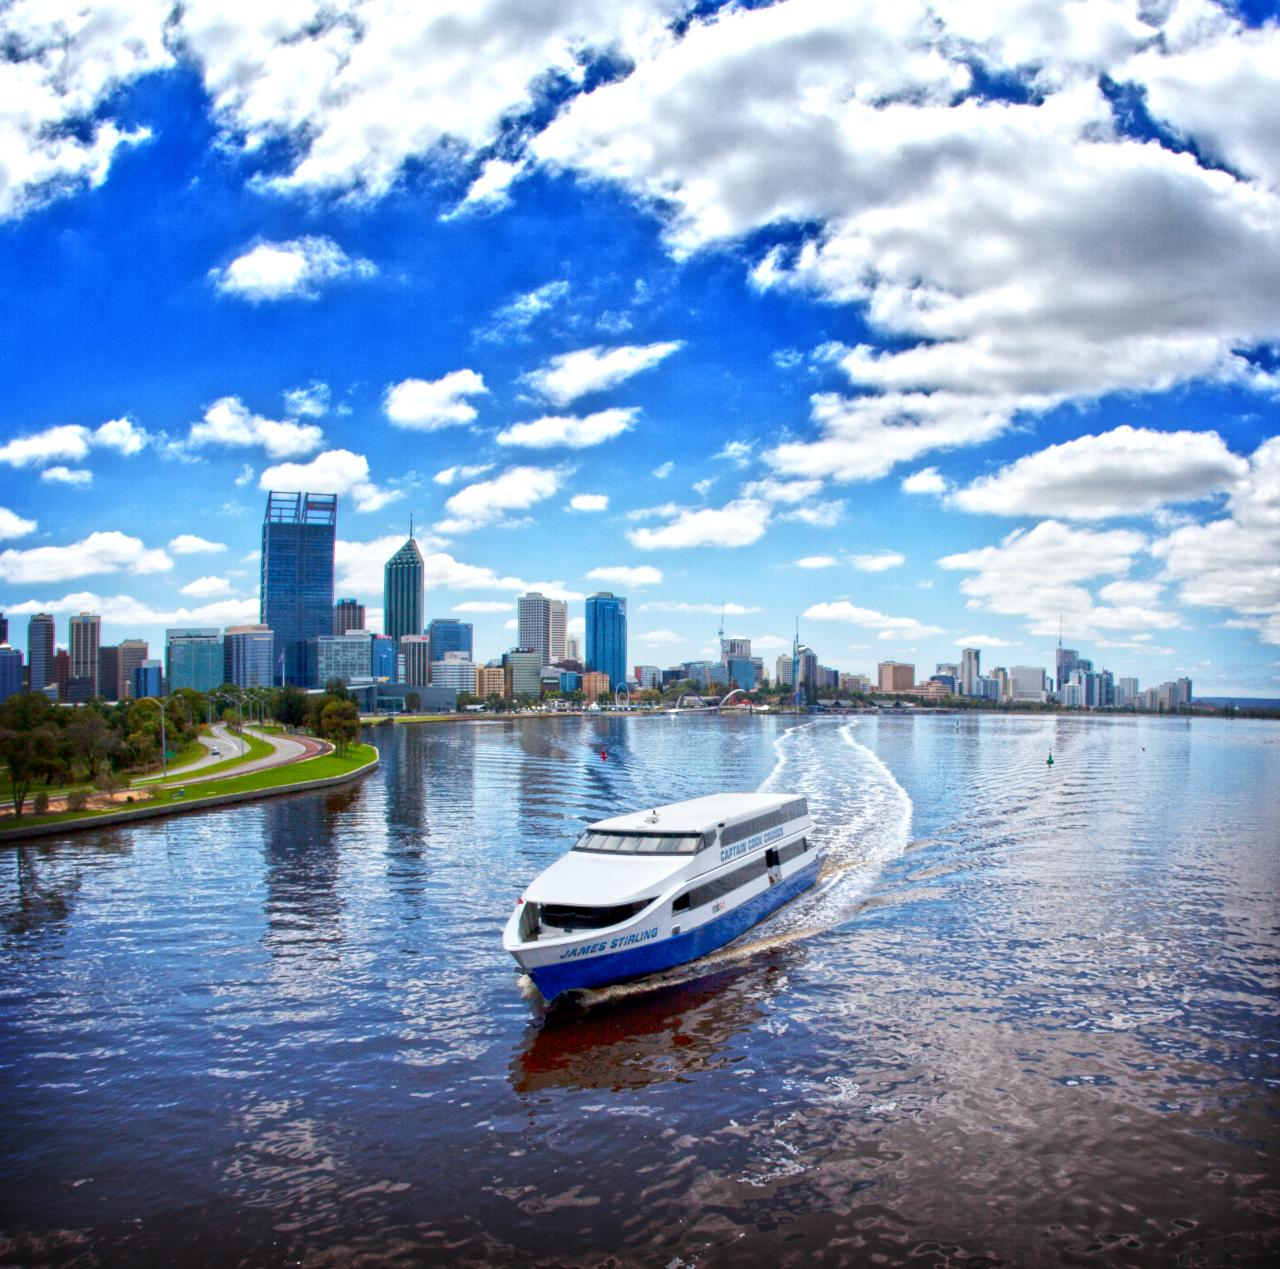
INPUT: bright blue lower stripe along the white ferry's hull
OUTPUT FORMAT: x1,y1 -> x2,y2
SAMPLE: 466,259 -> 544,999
529,857 -> 820,1000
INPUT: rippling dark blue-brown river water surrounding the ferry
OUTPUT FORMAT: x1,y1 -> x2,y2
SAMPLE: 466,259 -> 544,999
0,716 -> 1280,1266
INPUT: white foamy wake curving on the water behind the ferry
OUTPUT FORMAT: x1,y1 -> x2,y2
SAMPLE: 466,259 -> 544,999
560,720 -> 913,1008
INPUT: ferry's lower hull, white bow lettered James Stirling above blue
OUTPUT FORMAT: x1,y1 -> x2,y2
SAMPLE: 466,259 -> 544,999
504,850 -> 822,1001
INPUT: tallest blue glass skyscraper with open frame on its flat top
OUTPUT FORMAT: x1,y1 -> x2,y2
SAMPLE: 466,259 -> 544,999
259,493 -> 338,686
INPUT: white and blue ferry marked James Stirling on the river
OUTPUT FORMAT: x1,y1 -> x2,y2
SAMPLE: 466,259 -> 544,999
502,793 -> 820,1000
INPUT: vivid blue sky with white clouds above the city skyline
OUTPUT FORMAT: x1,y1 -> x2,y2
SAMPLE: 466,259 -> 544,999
0,0 -> 1280,695
